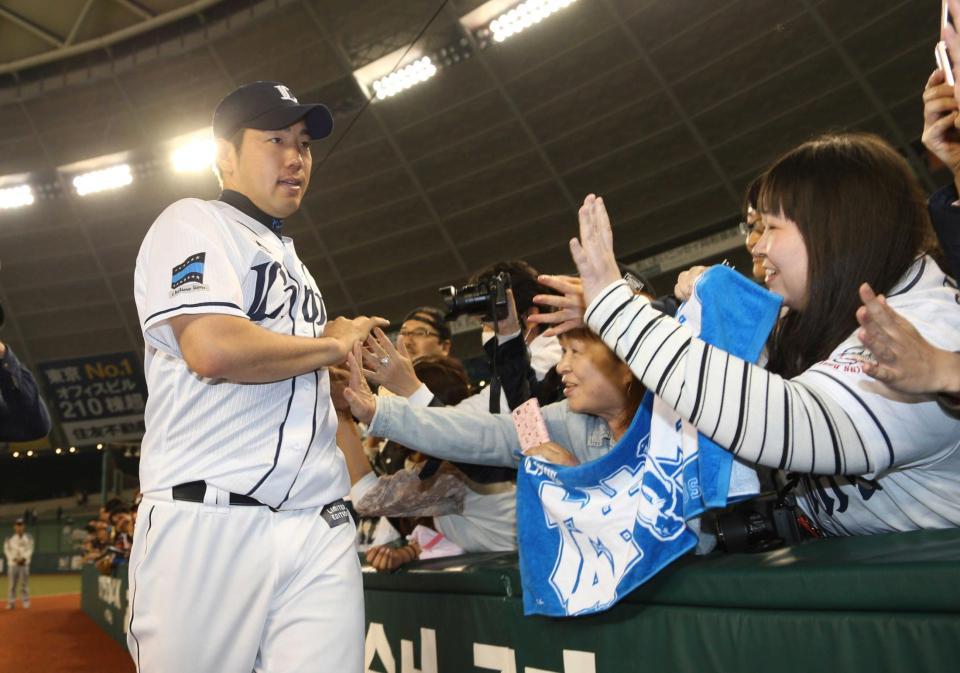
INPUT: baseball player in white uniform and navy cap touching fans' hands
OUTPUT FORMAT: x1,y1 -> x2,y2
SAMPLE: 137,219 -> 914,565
127,82 -> 386,673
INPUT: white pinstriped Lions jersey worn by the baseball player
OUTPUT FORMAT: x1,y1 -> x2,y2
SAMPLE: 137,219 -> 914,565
134,199 -> 349,509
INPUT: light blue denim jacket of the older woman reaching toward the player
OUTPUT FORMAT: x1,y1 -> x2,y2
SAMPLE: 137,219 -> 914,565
370,396 -> 613,467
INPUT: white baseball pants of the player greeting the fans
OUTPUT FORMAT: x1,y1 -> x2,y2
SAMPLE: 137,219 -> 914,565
127,494 -> 364,673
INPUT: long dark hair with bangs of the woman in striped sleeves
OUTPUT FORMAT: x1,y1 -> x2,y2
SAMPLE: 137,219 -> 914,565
758,133 -> 937,378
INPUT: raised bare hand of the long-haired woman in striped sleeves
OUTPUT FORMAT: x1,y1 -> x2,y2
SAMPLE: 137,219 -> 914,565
570,194 -> 620,306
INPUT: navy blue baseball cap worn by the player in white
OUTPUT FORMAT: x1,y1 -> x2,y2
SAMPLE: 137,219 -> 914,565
213,82 -> 333,140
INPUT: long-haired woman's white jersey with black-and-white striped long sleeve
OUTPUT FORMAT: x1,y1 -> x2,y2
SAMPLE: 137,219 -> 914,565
586,257 -> 960,534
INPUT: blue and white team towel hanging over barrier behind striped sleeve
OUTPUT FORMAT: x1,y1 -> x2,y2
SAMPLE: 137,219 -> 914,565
517,266 -> 781,616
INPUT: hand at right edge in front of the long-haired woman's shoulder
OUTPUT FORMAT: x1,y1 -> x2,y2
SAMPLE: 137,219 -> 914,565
857,283 -> 960,394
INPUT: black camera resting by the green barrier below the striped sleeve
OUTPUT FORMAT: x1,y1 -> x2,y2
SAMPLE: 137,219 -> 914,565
716,494 -> 803,554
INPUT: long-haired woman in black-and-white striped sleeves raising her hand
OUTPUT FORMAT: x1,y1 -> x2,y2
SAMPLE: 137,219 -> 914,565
540,134 -> 960,535
